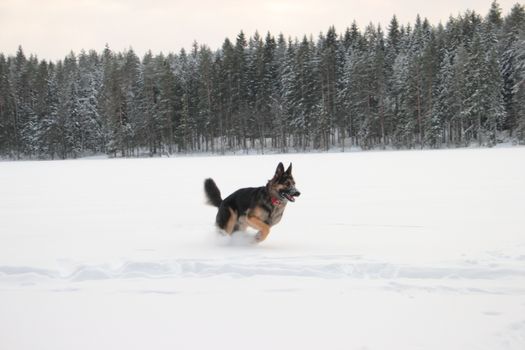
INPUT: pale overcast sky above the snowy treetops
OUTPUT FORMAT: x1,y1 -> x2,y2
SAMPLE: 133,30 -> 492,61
0,0 -> 517,60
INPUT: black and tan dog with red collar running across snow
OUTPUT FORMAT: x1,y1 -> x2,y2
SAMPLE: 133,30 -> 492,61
204,163 -> 301,242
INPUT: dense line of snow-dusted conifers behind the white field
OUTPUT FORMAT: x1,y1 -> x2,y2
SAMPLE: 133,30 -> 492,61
0,2 -> 525,159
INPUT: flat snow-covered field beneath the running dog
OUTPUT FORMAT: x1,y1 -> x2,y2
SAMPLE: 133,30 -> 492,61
0,148 -> 525,350
